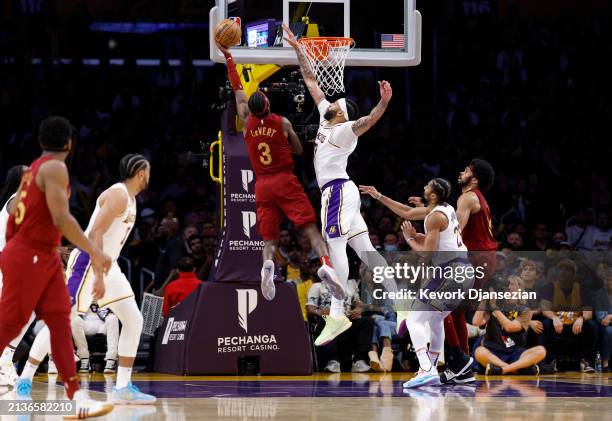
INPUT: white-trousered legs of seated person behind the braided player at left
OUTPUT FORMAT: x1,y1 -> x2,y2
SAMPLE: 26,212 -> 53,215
72,301 -> 119,374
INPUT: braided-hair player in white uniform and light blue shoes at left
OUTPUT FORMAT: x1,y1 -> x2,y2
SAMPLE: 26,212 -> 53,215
17,154 -> 156,404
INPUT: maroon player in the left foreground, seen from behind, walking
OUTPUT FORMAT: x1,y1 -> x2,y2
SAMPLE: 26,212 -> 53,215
0,117 -> 113,418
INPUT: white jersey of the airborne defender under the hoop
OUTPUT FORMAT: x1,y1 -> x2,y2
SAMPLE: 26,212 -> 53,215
314,99 -> 357,188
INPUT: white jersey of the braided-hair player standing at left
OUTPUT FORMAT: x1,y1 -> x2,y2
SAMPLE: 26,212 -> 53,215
85,183 -> 136,261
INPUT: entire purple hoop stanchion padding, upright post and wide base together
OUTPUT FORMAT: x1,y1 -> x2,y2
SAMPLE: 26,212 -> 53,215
155,101 -> 312,375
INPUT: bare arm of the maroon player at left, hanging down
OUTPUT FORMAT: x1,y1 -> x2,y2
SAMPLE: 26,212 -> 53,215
36,160 -> 111,272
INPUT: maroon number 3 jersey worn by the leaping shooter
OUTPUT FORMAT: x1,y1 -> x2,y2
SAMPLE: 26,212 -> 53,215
244,114 -> 293,177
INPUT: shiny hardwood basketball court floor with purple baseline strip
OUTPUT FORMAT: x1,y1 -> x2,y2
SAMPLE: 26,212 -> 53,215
2,373 -> 612,421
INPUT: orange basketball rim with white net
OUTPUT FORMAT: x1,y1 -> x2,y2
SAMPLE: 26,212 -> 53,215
299,37 -> 355,95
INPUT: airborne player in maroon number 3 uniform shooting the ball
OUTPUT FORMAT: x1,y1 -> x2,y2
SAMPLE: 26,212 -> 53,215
217,44 -> 345,300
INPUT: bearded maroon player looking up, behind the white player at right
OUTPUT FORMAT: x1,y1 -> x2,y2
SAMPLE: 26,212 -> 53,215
441,159 -> 497,383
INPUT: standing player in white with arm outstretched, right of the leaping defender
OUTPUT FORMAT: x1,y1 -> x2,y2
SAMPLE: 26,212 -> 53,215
360,178 -> 474,388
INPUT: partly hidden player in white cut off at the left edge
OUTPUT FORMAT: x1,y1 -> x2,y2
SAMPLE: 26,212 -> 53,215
0,165 -> 34,386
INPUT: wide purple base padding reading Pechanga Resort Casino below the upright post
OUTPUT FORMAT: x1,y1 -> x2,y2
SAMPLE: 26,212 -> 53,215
155,282 -> 312,375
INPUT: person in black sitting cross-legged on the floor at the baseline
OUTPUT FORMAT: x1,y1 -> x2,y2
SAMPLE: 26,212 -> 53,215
472,276 -> 546,375
